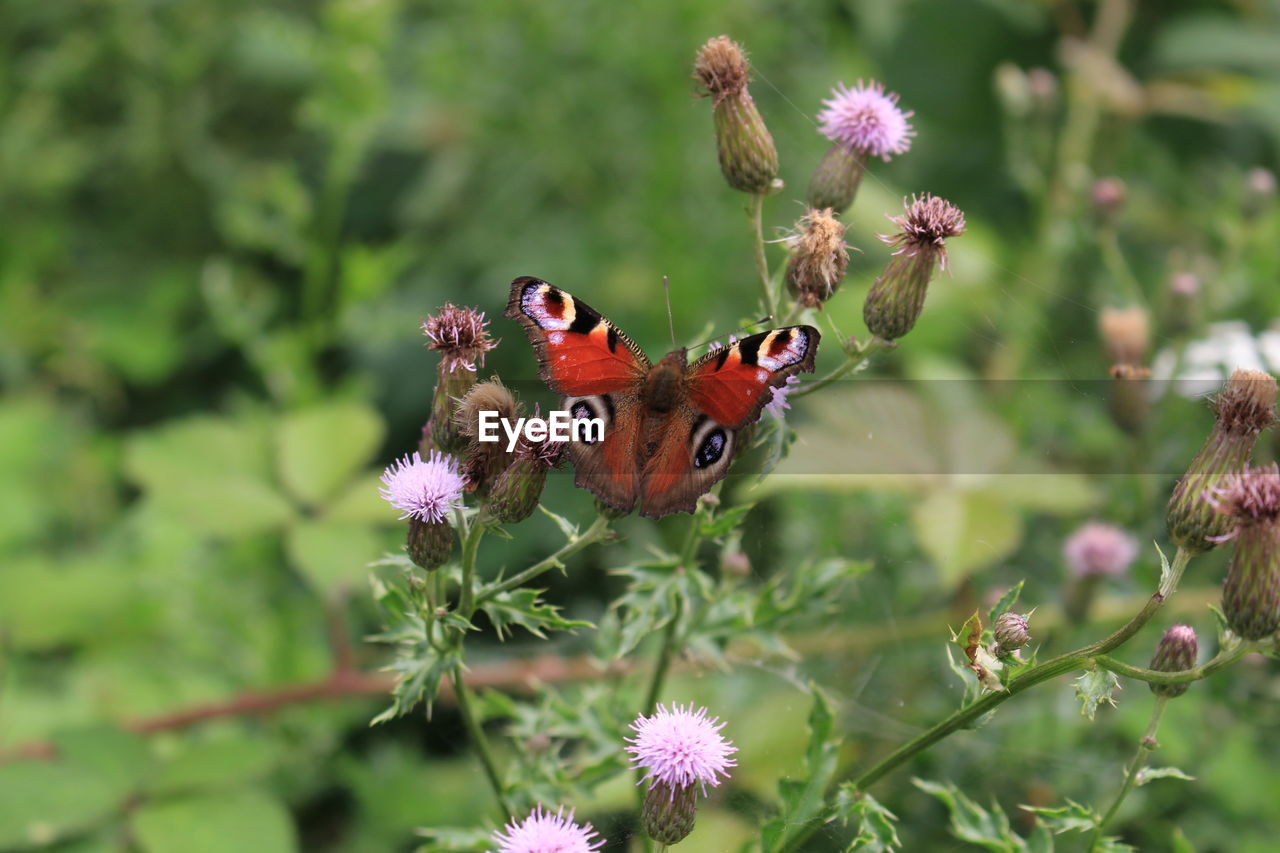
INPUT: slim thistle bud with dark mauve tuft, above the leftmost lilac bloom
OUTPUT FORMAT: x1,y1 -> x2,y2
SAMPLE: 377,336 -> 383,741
422,302 -> 497,452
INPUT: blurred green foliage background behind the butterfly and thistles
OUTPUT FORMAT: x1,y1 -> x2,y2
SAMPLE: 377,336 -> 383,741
0,0 -> 1280,853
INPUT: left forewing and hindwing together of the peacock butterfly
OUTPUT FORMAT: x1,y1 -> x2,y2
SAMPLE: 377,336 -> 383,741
506,275 -> 653,511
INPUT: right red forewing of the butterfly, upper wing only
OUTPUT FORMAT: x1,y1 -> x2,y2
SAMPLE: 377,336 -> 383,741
689,325 -> 822,429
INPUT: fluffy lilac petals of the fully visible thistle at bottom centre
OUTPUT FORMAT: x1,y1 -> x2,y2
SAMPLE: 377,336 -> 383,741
626,703 -> 737,794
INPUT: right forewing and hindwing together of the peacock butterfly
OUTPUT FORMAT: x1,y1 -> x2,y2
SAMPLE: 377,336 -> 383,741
640,325 -> 822,519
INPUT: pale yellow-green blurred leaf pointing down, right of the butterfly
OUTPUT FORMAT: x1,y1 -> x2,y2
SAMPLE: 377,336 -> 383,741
911,489 -> 1021,588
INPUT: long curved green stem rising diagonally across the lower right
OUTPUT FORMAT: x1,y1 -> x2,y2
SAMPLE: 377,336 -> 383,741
778,548 -> 1194,853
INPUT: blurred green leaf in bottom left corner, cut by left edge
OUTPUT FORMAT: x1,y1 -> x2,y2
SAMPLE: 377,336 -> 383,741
0,761 -> 129,849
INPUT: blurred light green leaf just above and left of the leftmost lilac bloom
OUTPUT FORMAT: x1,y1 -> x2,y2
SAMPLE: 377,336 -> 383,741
278,402 -> 384,506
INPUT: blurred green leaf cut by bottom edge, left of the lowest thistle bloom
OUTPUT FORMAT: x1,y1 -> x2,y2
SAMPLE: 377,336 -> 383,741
129,790 -> 298,853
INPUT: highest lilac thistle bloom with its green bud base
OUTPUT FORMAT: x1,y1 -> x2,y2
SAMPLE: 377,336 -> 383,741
809,81 -> 915,213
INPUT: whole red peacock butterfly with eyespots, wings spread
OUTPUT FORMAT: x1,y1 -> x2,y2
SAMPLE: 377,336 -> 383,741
506,275 -> 820,519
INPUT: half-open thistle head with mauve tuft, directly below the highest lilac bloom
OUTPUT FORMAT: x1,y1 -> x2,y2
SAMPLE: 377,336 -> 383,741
863,193 -> 964,341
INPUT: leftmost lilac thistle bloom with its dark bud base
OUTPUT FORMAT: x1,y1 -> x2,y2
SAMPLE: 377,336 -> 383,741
380,452 -> 463,569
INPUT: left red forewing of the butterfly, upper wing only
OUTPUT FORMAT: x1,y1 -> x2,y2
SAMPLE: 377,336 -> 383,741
506,275 -> 653,397
